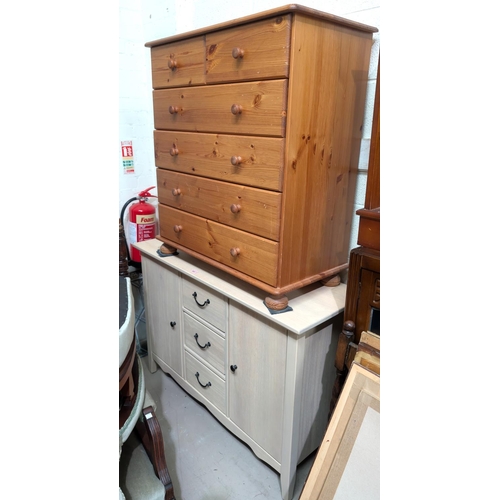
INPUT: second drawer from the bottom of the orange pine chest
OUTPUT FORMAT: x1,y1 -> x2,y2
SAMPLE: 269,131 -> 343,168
157,169 -> 281,241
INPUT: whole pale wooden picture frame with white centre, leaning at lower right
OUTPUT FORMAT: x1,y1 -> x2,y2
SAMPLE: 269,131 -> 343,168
300,361 -> 380,500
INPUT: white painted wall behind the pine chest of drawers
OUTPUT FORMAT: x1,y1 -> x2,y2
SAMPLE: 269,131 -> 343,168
117,0 -> 380,248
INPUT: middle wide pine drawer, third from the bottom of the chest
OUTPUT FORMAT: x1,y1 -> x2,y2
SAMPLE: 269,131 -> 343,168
154,130 -> 285,191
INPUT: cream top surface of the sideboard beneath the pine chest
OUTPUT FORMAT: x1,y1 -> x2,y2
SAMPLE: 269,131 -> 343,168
133,239 -> 347,335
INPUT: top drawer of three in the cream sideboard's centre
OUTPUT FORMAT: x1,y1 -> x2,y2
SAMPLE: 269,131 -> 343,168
182,278 -> 227,332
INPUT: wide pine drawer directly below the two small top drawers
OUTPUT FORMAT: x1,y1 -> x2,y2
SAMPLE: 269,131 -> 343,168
153,80 -> 288,137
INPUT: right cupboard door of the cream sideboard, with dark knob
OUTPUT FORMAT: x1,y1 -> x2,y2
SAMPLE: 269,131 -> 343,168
226,303 -> 287,463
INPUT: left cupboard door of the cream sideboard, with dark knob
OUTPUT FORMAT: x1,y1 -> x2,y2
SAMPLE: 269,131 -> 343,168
142,255 -> 182,376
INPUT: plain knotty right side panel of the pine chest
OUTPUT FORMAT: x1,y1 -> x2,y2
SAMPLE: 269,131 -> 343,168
278,15 -> 371,286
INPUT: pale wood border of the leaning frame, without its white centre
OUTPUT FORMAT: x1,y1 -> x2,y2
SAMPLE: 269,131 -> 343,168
300,362 -> 380,500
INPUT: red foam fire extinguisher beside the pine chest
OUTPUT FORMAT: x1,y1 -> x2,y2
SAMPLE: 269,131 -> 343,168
128,186 -> 157,262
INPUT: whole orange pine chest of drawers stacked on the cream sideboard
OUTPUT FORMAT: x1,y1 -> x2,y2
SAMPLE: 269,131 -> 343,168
146,5 -> 377,309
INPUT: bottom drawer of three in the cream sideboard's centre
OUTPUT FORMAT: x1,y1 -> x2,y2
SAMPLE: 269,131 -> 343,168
184,351 -> 226,413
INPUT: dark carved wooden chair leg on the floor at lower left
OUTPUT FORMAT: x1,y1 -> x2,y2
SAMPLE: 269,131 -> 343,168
136,406 -> 175,500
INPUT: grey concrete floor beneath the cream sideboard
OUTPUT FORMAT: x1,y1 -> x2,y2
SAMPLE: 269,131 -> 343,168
134,274 -> 314,500
